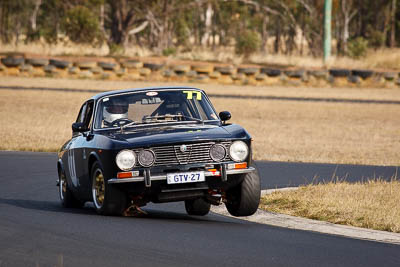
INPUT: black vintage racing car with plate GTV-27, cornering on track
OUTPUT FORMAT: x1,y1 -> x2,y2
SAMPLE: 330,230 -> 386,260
57,87 -> 260,216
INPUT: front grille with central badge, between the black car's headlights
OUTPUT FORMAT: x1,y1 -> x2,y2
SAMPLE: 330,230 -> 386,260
136,141 -> 232,166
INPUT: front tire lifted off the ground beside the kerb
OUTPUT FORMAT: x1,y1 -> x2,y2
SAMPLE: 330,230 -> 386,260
225,166 -> 261,217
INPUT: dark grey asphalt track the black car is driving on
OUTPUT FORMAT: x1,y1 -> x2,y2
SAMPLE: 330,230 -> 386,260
0,152 -> 400,267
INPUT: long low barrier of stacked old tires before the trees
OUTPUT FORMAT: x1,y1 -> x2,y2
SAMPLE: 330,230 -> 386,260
0,56 -> 400,87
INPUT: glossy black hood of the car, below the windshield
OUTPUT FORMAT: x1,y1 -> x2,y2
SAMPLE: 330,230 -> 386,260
104,125 -> 245,147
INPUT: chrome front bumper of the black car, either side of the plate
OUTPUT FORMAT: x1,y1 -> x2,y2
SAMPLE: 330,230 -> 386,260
108,167 -> 255,184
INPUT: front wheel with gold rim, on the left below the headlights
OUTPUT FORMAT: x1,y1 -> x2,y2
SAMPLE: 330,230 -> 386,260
90,162 -> 128,216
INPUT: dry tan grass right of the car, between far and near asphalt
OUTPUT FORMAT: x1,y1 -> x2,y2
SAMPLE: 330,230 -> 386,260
213,99 -> 400,165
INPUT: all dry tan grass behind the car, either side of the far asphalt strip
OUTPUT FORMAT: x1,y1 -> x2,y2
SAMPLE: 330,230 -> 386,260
0,77 -> 400,165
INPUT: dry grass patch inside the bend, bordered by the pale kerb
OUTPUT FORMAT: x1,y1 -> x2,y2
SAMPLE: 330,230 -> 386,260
260,180 -> 400,233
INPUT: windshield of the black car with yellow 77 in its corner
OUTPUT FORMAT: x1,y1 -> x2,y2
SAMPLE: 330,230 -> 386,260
95,89 -> 218,129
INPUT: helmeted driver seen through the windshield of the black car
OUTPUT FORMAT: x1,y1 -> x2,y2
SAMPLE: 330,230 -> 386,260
103,97 -> 129,126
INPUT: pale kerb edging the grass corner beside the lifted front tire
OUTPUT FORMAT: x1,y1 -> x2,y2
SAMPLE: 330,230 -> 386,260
211,187 -> 400,245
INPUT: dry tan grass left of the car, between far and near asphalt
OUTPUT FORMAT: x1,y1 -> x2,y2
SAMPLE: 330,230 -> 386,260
0,90 -> 92,151
